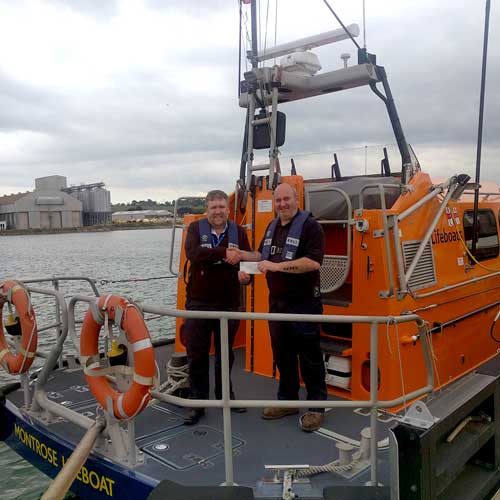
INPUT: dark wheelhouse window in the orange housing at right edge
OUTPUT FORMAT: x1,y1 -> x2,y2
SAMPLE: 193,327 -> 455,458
464,210 -> 498,260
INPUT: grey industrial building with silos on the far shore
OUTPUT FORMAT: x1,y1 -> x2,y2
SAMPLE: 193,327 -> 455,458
0,175 -> 111,230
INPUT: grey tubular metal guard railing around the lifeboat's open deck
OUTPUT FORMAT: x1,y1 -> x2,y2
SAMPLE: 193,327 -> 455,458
3,278 -> 434,485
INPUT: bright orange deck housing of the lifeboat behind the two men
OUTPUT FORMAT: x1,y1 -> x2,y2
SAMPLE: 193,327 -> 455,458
176,172 -> 500,406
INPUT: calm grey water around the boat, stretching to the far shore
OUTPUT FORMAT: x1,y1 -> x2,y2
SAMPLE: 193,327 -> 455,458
0,229 -> 180,500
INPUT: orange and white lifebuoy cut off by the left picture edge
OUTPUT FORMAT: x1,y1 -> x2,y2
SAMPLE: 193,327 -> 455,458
0,280 -> 38,374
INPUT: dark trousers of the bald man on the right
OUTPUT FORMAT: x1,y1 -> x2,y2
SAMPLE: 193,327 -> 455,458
269,298 -> 327,411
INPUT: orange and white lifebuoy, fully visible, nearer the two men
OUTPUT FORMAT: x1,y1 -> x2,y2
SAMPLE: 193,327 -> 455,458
80,295 -> 156,419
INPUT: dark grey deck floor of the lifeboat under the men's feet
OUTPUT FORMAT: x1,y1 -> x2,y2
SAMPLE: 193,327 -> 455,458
4,345 -> 391,498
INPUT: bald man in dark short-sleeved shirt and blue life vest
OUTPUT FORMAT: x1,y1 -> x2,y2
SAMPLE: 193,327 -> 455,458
241,183 -> 327,432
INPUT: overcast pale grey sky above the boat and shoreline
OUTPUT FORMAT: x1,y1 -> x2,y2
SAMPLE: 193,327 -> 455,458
0,0 -> 500,202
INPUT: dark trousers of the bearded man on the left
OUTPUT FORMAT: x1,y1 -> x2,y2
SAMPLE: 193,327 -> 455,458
184,318 -> 240,399
